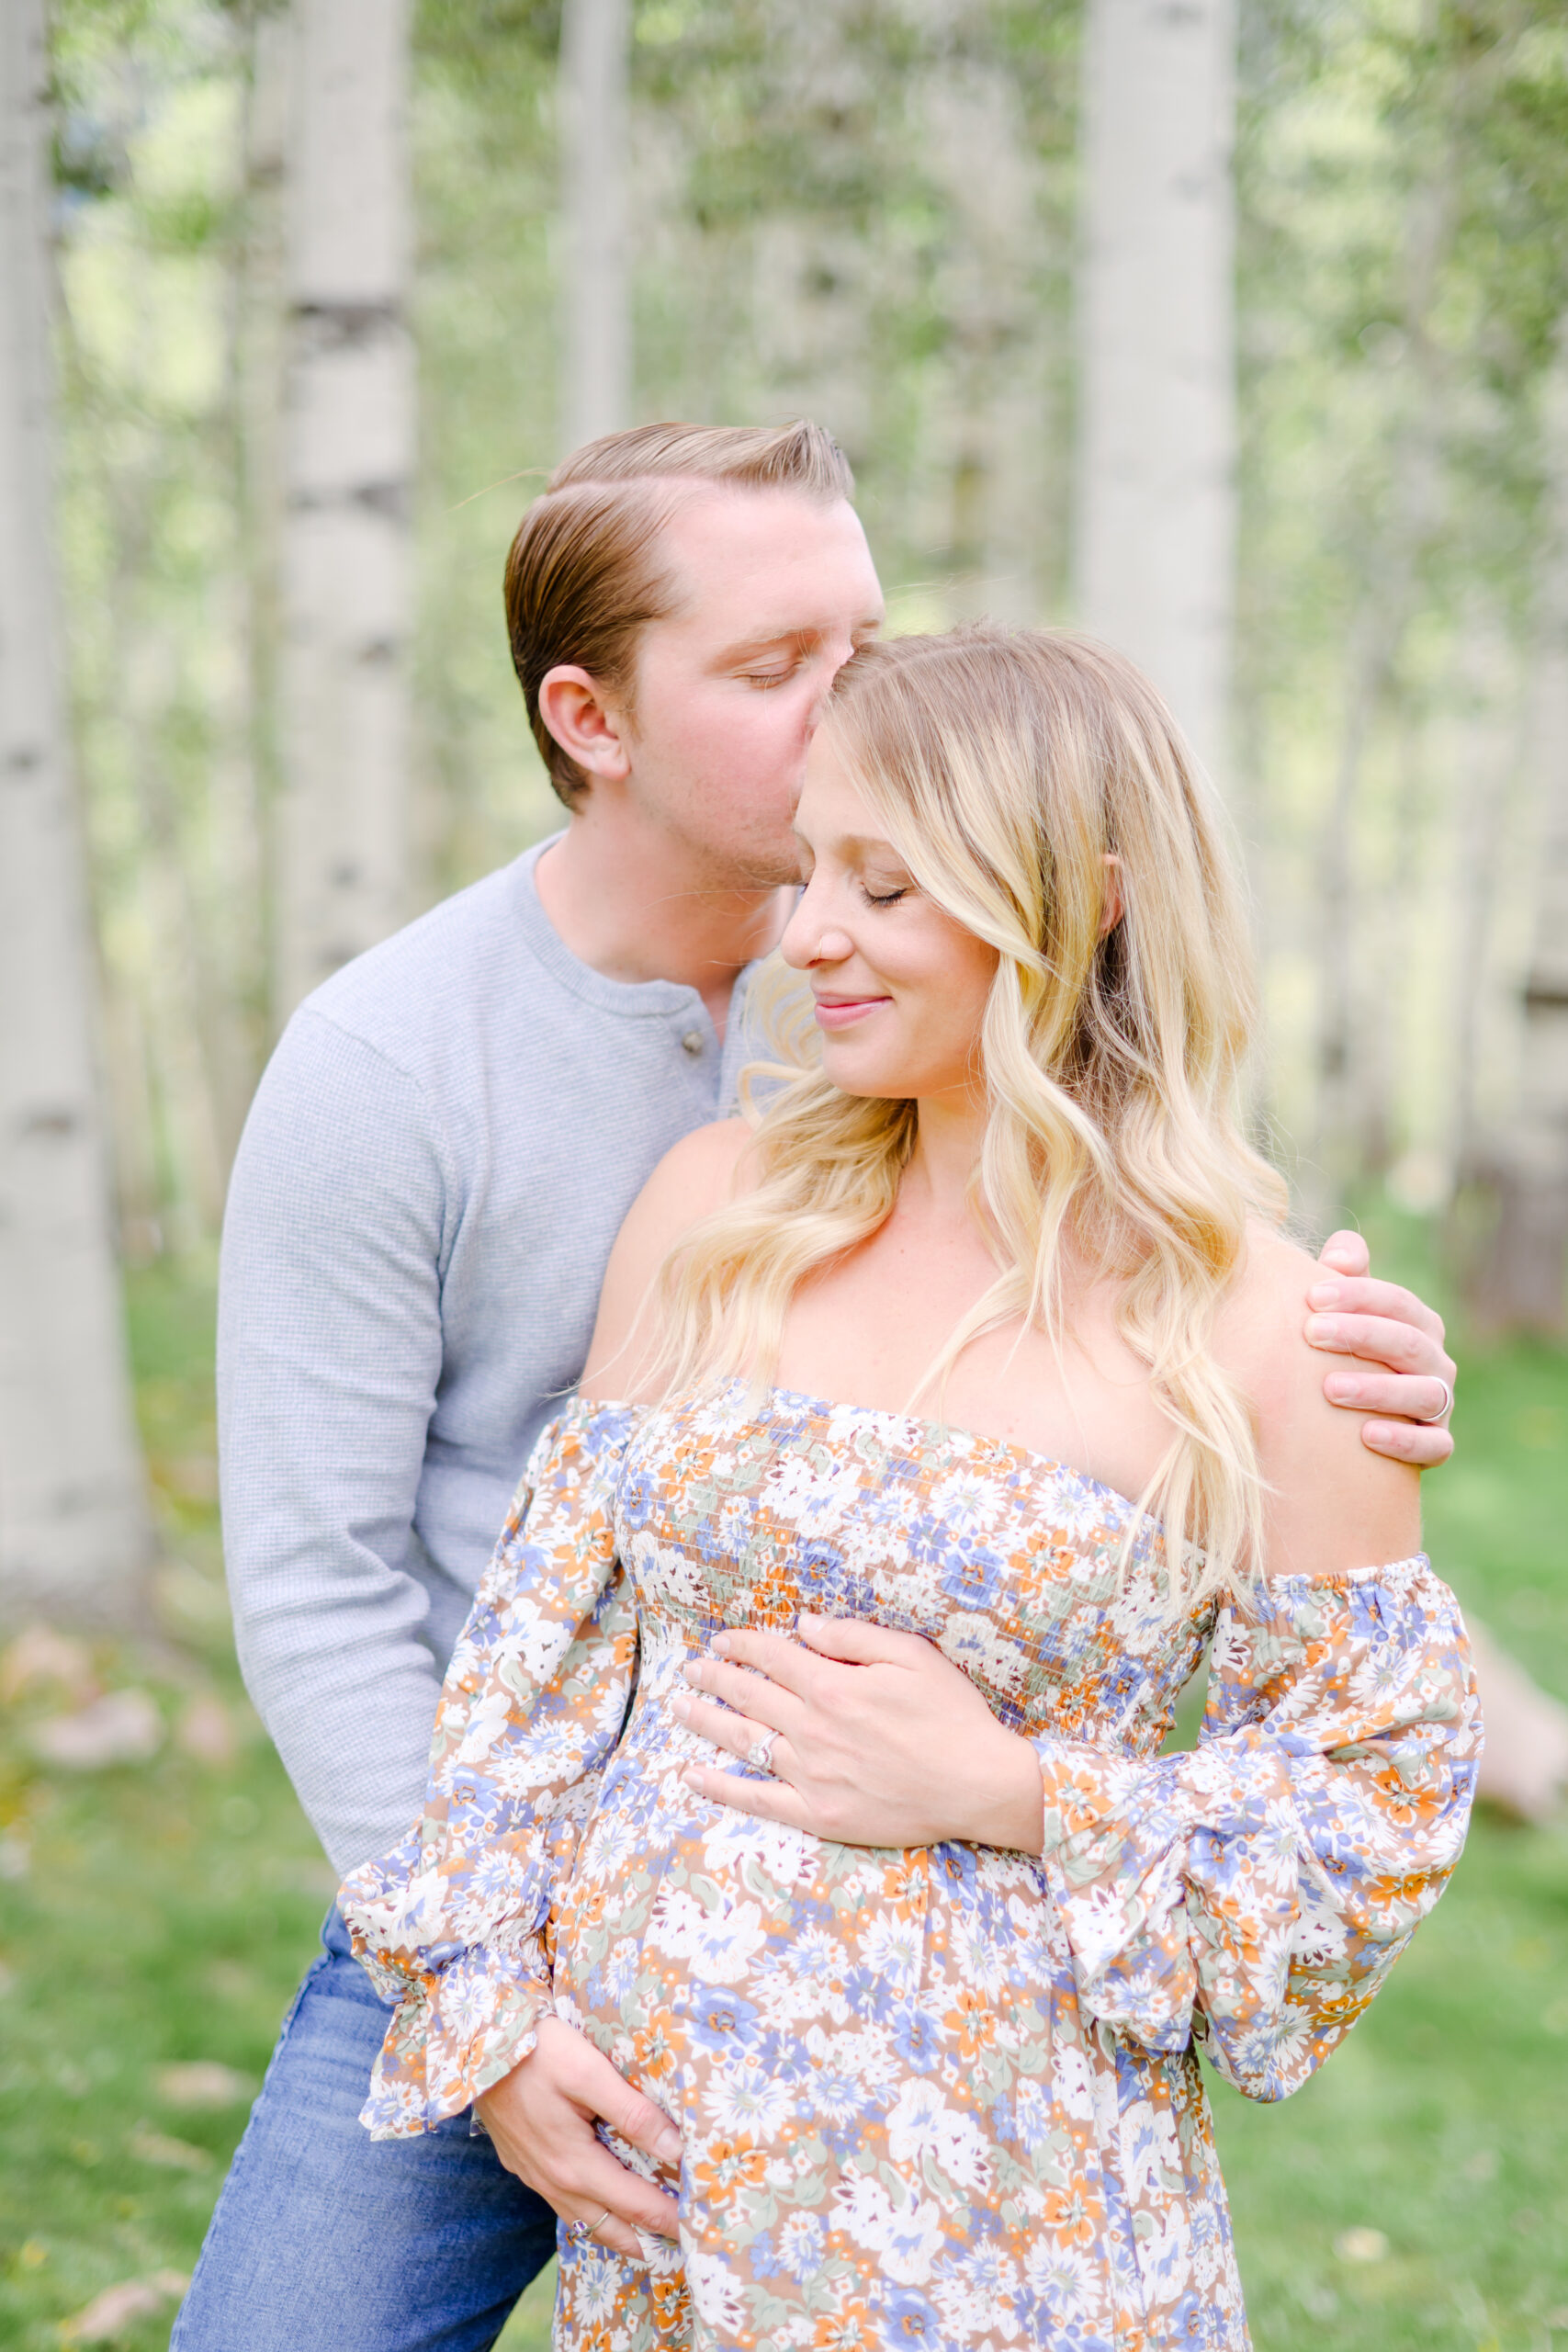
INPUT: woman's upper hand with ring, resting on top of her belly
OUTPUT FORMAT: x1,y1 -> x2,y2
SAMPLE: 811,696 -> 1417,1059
672,1616 -> 1043,1853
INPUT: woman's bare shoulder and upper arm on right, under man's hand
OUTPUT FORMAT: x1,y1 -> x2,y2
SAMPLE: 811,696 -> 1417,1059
1215,1223 -> 1420,1576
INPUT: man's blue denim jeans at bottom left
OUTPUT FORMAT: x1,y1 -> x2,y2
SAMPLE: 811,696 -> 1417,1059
169,1910 -> 555,2352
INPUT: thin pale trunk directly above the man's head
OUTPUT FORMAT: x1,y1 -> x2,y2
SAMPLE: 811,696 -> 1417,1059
559,0 -> 632,449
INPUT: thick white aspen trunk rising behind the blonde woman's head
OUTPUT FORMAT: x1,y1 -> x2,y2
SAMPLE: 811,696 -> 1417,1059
1075,0 -> 1236,778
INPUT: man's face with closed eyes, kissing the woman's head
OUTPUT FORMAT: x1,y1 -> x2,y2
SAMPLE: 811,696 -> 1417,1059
626,489 -> 882,889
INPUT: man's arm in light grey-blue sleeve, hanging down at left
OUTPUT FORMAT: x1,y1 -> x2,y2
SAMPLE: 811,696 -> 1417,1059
219,1012 -> 451,1872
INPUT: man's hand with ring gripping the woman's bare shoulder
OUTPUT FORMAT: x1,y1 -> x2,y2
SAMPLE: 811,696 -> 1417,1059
1304,1232 -> 1455,1470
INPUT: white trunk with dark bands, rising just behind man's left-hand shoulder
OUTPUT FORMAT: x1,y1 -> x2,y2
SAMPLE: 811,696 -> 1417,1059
273,0 -> 413,1021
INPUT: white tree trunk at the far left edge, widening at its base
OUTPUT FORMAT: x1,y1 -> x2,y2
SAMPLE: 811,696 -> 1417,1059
0,0 -> 151,1618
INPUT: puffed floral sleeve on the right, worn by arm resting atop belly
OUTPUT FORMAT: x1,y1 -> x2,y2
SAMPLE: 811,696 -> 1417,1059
1034,1557 -> 1481,2098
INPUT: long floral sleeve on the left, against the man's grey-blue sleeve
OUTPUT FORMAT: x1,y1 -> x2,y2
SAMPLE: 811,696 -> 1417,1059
339,1399 -> 637,2141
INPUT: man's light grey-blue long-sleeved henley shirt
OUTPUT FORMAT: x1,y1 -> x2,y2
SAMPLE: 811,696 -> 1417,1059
219,844 -> 766,1872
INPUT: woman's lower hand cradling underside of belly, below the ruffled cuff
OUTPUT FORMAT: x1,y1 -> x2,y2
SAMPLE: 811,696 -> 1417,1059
475,2018 -> 680,2263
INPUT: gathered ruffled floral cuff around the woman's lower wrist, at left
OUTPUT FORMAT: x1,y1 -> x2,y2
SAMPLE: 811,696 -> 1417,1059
339,1823 -> 579,2141
